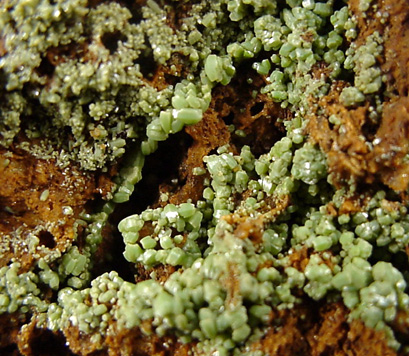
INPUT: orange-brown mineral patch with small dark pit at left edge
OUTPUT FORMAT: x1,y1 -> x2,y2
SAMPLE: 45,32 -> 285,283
0,145 -> 113,270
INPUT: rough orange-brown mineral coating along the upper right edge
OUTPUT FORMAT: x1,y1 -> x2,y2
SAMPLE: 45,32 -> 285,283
309,0 -> 409,192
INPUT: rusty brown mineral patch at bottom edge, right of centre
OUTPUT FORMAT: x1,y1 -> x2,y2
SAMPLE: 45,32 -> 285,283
249,303 -> 396,356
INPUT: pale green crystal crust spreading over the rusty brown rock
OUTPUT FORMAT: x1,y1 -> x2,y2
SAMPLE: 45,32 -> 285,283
0,0 -> 409,355
